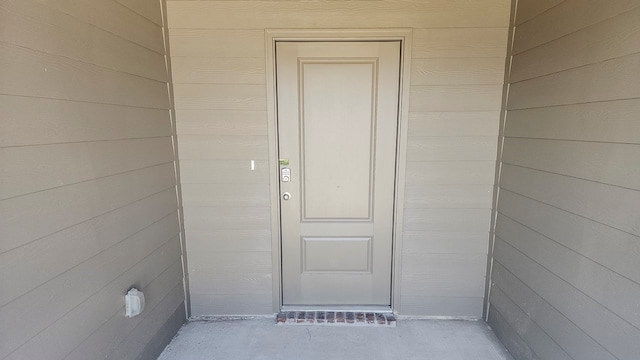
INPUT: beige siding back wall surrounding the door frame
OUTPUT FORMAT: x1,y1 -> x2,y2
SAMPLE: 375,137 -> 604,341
168,0 -> 510,316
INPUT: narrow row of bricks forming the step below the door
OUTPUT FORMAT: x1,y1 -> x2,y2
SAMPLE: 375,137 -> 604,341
276,311 -> 396,327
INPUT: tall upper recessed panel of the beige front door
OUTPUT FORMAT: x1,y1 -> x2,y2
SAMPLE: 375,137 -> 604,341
299,59 -> 377,221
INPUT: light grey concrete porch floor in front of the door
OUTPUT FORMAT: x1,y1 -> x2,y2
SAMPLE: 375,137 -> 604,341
158,318 -> 513,360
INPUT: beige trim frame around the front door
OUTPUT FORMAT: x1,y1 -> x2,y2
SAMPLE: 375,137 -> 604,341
265,28 -> 413,313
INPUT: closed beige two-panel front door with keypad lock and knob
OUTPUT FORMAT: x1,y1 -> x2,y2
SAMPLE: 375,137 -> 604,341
276,41 -> 400,306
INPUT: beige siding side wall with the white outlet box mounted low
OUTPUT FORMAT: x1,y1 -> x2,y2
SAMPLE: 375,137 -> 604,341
0,0 -> 184,360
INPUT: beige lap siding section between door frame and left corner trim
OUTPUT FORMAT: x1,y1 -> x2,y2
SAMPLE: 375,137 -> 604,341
169,23 -> 273,316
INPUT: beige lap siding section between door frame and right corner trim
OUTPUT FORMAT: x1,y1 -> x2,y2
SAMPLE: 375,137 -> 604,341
400,25 -> 508,317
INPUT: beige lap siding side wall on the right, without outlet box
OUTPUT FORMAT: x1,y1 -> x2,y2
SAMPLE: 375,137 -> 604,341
490,0 -> 640,360
